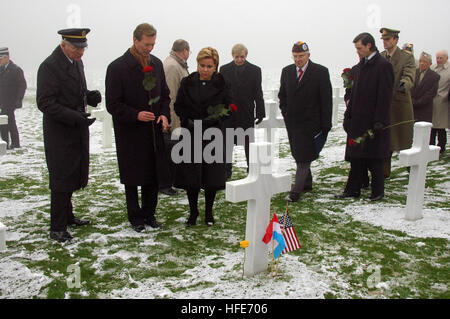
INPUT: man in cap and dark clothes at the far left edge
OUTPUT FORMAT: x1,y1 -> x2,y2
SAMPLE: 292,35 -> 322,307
0,48 -> 27,149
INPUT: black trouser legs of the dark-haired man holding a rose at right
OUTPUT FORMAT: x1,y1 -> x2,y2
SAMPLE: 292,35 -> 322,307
345,158 -> 384,197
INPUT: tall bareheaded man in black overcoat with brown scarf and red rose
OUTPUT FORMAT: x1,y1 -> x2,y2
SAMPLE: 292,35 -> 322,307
106,23 -> 170,232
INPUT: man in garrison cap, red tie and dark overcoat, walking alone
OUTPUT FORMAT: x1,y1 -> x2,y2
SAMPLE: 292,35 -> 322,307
278,42 -> 333,202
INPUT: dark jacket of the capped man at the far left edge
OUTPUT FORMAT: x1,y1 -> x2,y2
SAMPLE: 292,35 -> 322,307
0,61 -> 27,111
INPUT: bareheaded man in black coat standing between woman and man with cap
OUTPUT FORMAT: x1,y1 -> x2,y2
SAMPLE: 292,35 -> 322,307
220,44 -> 266,178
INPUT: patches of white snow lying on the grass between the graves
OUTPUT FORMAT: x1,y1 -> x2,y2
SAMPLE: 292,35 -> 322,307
0,74 -> 450,298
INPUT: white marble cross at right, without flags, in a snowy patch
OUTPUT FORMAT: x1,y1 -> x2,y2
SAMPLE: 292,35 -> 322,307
399,122 -> 440,221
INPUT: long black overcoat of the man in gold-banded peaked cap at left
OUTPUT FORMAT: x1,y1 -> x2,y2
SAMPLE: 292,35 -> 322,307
36,46 -> 96,192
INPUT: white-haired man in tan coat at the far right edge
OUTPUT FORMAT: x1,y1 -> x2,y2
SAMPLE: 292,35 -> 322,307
430,50 -> 450,154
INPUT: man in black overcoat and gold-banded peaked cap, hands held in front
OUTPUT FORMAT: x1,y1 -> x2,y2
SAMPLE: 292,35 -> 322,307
36,29 -> 102,242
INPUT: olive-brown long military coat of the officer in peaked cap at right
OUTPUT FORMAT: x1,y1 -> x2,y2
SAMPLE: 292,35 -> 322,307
381,47 -> 416,151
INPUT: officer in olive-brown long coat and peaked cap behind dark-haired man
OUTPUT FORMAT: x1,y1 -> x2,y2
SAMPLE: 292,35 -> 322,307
380,28 -> 416,178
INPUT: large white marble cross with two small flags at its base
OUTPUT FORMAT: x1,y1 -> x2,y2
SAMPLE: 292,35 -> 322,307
225,142 -> 291,276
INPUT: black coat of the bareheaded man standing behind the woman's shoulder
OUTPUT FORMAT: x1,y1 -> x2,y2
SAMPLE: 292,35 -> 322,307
220,61 -> 266,130
